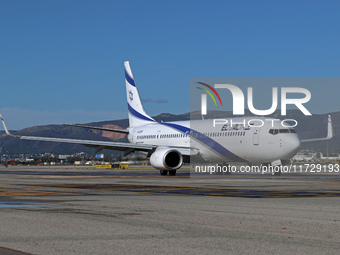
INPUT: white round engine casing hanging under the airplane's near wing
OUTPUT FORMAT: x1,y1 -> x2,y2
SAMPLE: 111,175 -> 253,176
150,148 -> 183,170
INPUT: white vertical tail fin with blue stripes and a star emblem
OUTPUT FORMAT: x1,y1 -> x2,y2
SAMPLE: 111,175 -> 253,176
124,61 -> 155,127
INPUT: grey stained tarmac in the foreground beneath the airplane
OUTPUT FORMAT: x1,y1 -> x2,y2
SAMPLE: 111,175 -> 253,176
0,166 -> 340,255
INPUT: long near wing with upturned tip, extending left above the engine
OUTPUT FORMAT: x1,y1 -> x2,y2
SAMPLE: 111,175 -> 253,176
0,113 -> 198,156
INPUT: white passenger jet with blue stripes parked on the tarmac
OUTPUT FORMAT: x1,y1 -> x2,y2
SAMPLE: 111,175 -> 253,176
0,61 -> 333,175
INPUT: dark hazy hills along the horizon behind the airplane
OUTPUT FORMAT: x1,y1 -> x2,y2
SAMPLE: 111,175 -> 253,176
0,110 -> 340,154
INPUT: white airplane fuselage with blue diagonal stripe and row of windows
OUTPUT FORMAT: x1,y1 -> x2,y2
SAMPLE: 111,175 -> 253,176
128,117 -> 300,163
